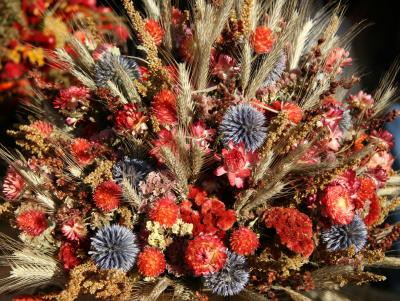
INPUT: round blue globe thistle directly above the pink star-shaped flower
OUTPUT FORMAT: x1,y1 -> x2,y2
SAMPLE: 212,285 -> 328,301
220,104 -> 267,151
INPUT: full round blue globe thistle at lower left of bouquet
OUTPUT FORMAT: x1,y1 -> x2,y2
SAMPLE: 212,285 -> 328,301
89,225 -> 139,272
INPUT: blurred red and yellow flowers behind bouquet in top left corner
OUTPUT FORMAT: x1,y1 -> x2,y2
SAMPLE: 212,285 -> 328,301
0,0 -> 129,101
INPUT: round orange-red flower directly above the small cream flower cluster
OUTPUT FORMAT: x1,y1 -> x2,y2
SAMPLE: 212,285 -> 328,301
149,198 -> 179,227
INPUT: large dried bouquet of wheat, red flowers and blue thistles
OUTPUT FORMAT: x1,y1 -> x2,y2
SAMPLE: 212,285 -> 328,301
0,0 -> 400,301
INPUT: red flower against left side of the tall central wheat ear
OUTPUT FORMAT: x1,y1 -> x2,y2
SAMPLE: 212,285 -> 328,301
152,89 -> 178,125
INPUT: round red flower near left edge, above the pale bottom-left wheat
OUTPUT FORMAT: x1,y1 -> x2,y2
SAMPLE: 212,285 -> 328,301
16,209 -> 48,236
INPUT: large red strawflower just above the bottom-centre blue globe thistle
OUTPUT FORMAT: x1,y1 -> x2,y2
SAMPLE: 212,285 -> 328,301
185,235 -> 227,276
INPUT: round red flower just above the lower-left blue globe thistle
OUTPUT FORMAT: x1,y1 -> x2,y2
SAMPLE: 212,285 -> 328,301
93,181 -> 122,212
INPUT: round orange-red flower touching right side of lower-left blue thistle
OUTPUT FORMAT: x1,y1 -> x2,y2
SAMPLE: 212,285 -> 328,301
137,247 -> 166,277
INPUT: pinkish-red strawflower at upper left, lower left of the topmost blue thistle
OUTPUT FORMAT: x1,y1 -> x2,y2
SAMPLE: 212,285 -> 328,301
53,86 -> 90,111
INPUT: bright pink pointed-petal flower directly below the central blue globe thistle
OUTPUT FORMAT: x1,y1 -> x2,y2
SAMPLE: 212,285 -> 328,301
215,142 -> 258,188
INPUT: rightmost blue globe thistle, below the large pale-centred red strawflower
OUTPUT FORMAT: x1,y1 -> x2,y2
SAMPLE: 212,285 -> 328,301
321,215 -> 368,252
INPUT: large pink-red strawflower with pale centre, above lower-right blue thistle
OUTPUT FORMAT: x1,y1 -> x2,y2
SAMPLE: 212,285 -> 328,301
321,184 -> 354,225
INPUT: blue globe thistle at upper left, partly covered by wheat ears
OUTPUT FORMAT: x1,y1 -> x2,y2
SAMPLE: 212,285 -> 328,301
94,52 -> 140,87
